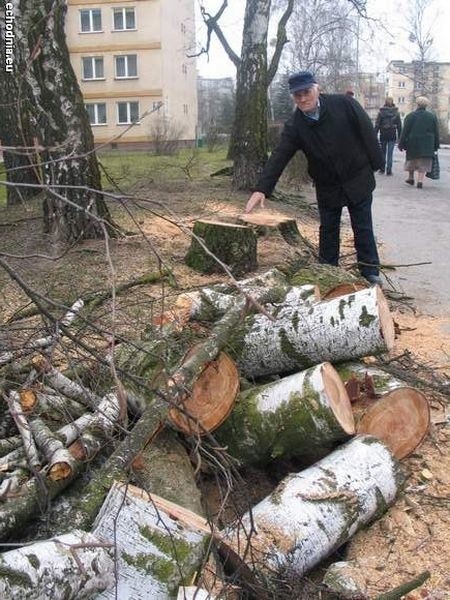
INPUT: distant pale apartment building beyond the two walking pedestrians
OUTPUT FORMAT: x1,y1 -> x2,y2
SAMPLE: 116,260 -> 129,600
386,60 -> 450,128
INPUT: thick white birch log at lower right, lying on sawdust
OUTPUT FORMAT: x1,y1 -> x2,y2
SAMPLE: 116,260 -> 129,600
221,436 -> 403,585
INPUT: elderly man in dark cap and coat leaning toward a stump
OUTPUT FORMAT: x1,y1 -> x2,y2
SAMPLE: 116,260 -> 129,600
245,71 -> 384,284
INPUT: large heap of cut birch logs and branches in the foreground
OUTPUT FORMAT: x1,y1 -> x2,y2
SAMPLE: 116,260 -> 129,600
0,269 -> 429,599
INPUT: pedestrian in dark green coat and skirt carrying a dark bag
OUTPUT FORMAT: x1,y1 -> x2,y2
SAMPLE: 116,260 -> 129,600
398,96 -> 439,189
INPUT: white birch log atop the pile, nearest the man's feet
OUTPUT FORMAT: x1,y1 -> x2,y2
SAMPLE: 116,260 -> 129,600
228,286 -> 394,377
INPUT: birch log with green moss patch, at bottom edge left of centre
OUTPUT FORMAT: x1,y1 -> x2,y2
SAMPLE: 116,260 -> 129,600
93,484 -> 211,600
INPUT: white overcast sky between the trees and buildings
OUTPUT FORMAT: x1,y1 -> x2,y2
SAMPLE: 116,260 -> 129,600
197,0 -> 450,78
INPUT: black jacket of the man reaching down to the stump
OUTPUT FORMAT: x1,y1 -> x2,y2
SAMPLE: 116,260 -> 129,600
255,94 -> 384,208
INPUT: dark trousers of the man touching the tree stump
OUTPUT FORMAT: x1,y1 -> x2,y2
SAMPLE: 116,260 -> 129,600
319,195 -> 380,277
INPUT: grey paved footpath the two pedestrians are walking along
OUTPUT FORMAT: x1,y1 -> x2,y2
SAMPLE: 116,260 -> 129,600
373,149 -> 450,333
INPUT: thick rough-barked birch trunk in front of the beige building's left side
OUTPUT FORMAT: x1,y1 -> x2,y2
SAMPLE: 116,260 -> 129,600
12,0 -> 112,242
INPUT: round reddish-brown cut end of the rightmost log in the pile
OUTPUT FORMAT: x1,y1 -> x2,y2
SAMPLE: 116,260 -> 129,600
357,387 -> 430,459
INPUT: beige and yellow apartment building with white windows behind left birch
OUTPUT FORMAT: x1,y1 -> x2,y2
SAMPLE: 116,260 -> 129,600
66,0 -> 197,147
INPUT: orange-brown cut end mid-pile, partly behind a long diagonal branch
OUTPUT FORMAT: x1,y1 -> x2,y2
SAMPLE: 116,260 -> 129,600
169,348 -> 239,435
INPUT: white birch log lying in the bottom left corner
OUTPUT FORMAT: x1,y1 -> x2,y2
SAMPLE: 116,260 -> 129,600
0,530 -> 114,600
